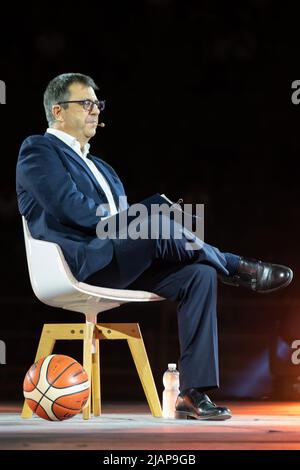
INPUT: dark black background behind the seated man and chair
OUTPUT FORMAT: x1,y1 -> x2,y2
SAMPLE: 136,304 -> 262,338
0,0 -> 300,401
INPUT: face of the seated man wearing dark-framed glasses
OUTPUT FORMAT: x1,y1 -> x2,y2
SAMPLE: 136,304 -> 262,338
54,83 -> 100,143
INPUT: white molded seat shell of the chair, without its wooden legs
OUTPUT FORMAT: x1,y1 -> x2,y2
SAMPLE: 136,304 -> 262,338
22,217 -> 163,314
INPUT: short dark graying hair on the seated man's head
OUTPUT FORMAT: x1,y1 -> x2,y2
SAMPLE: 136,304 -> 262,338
44,73 -> 99,126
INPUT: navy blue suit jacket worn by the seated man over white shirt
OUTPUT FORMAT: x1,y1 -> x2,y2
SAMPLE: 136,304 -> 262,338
16,133 -> 125,281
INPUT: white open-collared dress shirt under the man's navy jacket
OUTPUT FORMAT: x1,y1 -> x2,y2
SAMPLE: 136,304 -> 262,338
47,128 -> 118,215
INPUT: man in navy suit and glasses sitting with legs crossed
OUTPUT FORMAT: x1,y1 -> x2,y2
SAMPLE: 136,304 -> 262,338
17,73 -> 293,420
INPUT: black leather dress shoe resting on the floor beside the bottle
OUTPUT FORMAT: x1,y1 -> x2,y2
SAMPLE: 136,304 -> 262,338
175,388 -> 231,421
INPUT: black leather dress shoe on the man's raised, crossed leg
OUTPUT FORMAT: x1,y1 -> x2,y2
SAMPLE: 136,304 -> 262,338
220,258 -> 293,293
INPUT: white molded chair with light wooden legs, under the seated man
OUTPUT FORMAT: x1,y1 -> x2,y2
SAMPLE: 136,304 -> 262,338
22,217 -> 164,419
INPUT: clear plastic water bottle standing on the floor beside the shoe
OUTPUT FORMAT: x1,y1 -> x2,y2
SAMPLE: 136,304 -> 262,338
163,364 -> 179,418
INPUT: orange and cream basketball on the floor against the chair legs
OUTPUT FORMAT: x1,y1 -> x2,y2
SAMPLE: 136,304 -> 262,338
23,354 -> 90,421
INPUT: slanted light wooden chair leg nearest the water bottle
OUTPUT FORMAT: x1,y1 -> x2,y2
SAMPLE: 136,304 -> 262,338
127,324 -> 162,417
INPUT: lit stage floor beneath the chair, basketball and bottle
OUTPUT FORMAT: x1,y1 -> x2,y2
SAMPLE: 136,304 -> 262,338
0,402 -> 300,450
